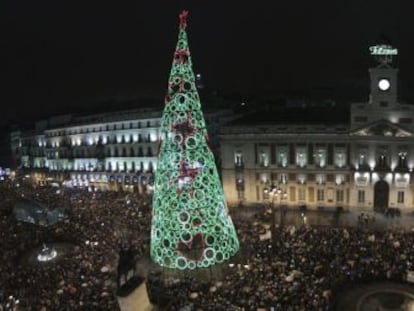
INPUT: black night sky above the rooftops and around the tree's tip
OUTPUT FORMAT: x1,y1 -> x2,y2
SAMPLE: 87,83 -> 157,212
0,0 -> 414,124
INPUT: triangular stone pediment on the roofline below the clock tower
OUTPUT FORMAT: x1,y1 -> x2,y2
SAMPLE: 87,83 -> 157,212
350,120 -> 413,137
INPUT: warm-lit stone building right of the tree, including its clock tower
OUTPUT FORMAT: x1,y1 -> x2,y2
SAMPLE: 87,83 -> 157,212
221,45 -> 414,212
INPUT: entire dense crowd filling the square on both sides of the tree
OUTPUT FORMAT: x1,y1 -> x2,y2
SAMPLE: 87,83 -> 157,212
0,177 -> 414,311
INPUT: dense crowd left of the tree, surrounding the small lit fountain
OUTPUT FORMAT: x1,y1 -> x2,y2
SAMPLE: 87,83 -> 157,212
0,183 -> 150,311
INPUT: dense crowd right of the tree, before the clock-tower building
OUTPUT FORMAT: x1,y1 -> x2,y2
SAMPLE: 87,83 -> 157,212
160,222 -> 414,310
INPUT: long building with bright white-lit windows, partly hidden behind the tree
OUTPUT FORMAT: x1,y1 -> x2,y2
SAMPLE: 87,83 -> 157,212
11,109 -> 234,192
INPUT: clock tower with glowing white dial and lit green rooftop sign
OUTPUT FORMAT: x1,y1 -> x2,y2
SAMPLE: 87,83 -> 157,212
369,39 -> 398,108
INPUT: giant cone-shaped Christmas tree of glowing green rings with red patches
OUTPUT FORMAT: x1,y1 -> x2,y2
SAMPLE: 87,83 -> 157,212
151,11 -> 239,270
